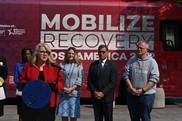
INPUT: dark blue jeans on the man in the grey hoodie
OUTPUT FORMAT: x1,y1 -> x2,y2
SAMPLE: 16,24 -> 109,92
127,93 -> 155,121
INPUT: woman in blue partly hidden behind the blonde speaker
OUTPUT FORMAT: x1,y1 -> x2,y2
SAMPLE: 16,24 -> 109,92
14,48 -> 32,121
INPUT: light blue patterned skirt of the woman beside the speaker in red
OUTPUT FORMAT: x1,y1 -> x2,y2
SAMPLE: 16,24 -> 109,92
57,95 -> 80,118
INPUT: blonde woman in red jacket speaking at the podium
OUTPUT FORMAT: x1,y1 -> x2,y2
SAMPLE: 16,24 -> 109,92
20,43 -> 64,121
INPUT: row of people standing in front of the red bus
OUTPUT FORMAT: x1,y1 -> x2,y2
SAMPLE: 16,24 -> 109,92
0,41 -> 159,121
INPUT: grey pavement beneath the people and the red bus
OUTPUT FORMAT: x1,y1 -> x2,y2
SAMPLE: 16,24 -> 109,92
0,98 -> 182,121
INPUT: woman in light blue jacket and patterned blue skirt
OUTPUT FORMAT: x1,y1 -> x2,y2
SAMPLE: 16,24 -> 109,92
57,47 -> 84,121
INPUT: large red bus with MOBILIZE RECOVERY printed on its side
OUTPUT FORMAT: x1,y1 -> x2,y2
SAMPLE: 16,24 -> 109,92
0,0 -> 182,98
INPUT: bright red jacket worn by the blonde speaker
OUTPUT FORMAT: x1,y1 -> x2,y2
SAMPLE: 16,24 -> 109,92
20,62 -> 64,107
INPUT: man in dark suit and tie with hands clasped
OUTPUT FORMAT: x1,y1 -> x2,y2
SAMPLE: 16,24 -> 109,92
87,45 -> 117,121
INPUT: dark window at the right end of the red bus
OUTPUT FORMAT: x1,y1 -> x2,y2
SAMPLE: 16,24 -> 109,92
160,20 -> 182,50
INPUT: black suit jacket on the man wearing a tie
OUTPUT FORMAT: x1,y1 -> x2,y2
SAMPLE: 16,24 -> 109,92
87,59 -> 117,102
